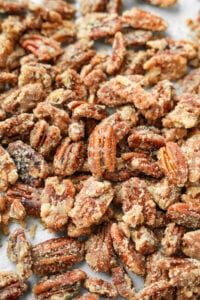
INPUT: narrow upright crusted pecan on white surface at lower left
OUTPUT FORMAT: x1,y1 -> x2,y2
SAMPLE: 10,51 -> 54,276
7,229 -> 32,280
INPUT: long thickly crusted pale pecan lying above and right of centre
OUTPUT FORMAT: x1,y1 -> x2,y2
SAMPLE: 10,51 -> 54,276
97,75 -> 155,109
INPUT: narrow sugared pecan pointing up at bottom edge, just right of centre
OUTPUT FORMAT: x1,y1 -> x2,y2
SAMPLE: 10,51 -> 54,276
112,266 -> 135,300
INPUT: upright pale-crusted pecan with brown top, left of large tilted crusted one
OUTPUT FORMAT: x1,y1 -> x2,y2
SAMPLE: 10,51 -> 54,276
40,177 -> 75,230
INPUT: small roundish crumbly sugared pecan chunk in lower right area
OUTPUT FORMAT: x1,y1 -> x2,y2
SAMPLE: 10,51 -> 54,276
131,226 -> 158,254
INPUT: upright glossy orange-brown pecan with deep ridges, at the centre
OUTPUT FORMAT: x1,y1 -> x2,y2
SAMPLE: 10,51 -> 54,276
88,121 -> 117,178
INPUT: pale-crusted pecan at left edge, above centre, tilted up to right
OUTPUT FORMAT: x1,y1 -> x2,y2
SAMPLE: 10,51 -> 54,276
2,83 -> 46,114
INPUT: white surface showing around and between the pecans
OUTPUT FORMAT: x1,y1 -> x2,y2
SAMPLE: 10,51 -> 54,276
0,0 -> 200,300
